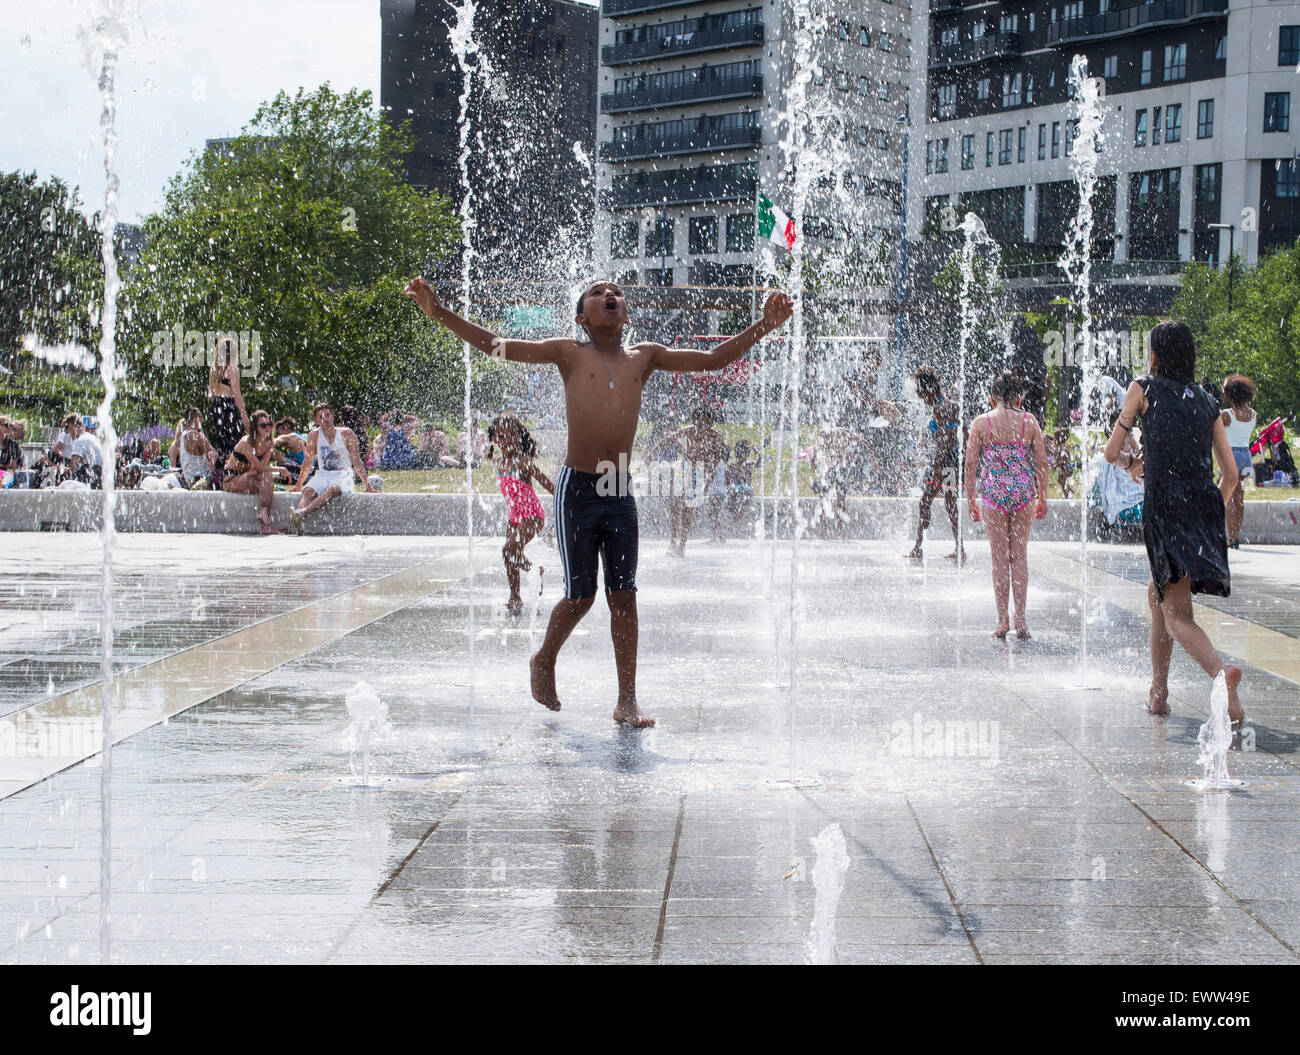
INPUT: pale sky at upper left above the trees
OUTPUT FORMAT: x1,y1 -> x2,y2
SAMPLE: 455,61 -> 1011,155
0,0 -> 380,221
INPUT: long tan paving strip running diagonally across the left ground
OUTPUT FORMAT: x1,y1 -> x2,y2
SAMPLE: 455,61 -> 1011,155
0,551 -> 495,800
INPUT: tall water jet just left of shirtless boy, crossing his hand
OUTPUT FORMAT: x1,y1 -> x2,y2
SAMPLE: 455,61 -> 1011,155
447,0 -> 482,718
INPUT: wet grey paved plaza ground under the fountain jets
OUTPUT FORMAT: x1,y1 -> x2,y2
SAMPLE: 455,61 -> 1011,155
0,537 -> 1300,964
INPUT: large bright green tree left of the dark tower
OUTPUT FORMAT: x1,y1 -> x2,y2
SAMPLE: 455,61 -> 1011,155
120,84 -> 496,420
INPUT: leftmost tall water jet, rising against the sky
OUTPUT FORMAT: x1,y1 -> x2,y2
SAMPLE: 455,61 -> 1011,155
79,0 -> 129,963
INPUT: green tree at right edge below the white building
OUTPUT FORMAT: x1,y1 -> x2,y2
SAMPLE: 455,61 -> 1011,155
1171,247 -> 1300,421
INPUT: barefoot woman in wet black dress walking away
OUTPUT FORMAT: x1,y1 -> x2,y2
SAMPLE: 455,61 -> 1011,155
1105,322 -> 1245,729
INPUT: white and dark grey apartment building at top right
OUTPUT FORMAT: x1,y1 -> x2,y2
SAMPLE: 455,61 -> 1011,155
909,0 -> 1300,282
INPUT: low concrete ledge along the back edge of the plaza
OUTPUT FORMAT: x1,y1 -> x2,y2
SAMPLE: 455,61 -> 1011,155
0,490 -> 1300,546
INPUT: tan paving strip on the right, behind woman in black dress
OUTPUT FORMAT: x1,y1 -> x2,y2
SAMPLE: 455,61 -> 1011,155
1032,550 -> 1300,685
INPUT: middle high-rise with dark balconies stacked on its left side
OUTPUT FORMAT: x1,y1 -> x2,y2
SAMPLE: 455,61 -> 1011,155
595,0 -> 911,315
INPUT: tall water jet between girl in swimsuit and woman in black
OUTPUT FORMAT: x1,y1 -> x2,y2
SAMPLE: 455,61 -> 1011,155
1057,55 -> 1105,687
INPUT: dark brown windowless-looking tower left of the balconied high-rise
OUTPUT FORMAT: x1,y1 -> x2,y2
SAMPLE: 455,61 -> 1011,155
380,0 -> 597,277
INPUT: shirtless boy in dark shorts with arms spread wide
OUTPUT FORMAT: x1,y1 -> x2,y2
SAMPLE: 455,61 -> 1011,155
406,278 -> 793,729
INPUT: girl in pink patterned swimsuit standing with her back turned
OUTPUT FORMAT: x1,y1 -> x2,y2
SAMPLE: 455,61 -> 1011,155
966,373 -> 1048,641
